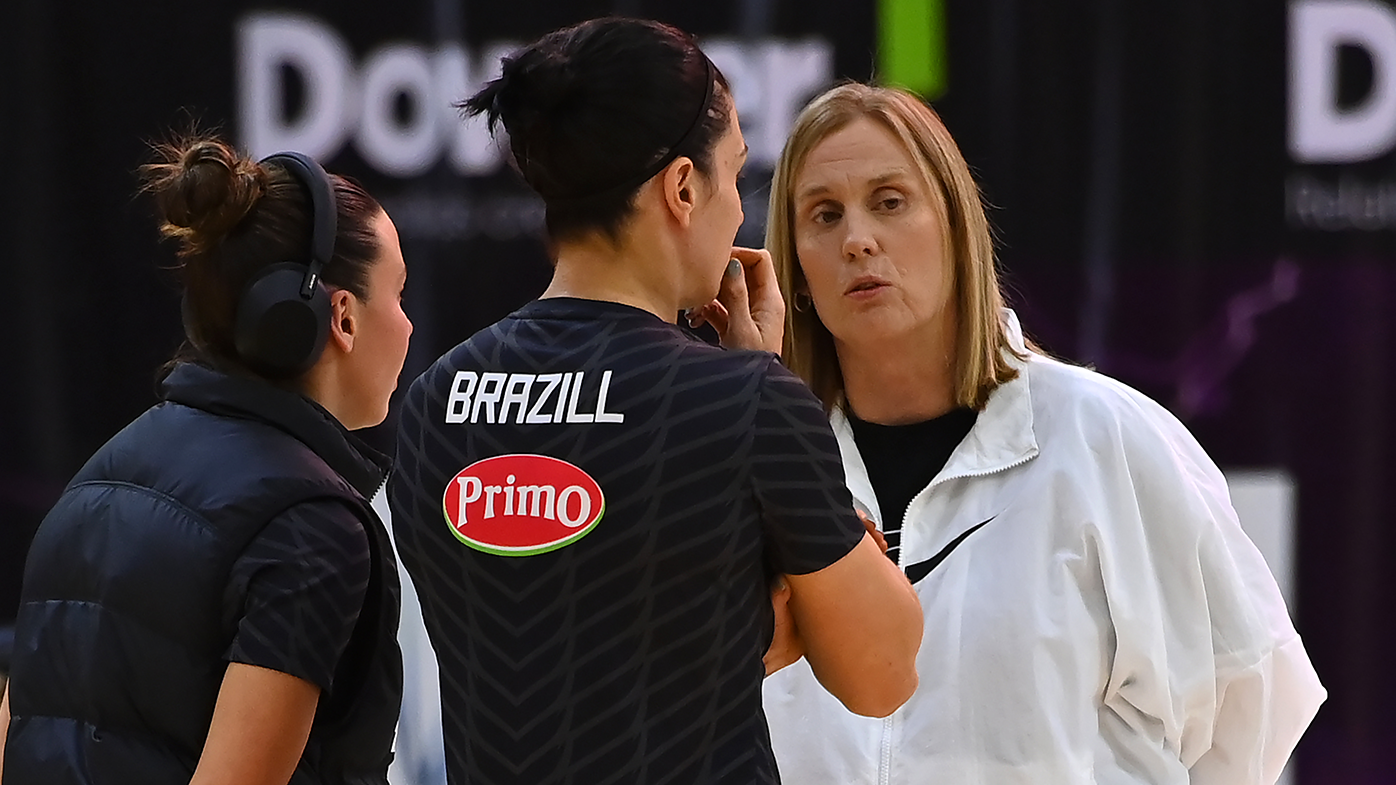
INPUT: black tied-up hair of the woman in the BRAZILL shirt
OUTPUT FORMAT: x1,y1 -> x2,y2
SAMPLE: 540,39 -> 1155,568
458,17 -> 732,240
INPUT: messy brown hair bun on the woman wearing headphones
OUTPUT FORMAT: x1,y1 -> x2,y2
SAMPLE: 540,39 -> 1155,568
141,137 -> 267,256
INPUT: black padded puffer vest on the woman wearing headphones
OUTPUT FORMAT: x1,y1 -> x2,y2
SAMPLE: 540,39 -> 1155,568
4,365 -> 402,785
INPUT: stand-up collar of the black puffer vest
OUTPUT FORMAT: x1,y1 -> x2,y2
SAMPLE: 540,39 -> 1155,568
161,363 -> 392,499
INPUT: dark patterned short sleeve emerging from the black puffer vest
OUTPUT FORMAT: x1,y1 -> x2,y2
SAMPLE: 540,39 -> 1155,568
223,500 -> 370,691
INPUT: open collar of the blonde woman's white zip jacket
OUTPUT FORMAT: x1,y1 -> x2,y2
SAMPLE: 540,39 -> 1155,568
831,309 -> 1037,499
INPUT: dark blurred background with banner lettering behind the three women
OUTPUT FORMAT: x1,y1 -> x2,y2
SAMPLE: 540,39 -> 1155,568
0,0 -> 1396,785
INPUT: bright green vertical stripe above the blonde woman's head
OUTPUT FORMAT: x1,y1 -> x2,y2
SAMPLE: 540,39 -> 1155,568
877,0 -> 949,99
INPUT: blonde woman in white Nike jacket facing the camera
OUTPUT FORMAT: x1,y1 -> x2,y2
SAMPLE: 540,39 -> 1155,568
765,84 -> 1325,785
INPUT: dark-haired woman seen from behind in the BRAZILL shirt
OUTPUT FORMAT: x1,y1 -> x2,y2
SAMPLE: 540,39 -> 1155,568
389,20 -> 920,785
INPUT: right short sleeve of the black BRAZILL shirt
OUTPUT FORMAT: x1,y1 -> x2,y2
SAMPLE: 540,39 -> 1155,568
751,359 -> 866,575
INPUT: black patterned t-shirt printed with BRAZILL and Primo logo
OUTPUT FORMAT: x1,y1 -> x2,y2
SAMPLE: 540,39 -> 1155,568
389,299 -> 863,785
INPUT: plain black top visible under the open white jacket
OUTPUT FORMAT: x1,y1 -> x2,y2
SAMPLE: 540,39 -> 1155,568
846,409 -> 979,564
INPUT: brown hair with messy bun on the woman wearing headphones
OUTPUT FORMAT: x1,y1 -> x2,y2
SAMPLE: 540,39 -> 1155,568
141,134 -> 383,370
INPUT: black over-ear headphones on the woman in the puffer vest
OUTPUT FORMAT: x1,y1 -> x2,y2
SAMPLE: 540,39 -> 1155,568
233,152 -> 338,379
